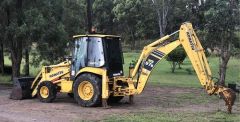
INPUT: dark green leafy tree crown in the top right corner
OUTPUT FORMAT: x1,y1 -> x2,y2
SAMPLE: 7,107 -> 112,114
205,0 -> 240,48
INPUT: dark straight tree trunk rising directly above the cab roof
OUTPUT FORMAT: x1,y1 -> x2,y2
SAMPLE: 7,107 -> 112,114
87,0 -> 92,33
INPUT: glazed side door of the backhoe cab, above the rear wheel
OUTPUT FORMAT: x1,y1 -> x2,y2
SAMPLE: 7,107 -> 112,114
71,37 -> 105,78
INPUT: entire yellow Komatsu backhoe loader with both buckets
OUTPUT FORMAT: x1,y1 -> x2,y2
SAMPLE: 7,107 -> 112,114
11,22 -> 236,112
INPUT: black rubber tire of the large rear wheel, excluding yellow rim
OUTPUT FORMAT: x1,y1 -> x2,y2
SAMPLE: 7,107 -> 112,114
73,73 -> 102,107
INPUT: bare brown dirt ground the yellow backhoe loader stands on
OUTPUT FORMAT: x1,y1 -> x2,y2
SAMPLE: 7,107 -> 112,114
0,85 -> 240,122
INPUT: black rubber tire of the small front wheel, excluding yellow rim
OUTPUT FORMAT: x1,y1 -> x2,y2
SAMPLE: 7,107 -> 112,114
37,81 -> 57,103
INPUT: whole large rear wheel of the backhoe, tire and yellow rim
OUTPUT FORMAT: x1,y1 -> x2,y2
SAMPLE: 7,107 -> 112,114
73,73 -> 102,107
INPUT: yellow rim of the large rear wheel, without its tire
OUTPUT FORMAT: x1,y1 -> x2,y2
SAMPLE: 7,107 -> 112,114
78,81 -> 94,100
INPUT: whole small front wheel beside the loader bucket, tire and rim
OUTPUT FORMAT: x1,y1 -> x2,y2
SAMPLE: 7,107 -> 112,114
38,81 -> 57,103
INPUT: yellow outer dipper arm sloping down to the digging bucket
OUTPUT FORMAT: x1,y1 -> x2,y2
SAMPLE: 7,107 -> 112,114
179,23 -> 210,86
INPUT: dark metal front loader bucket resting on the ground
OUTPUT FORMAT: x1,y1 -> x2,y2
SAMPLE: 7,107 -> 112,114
10,77 -> 34,100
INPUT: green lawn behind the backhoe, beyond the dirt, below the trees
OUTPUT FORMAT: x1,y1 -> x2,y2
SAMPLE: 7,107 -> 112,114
0,53 -> 240,87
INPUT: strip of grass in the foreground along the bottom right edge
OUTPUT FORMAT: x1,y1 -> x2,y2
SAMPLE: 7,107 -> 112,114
103,111 -> 240,122
